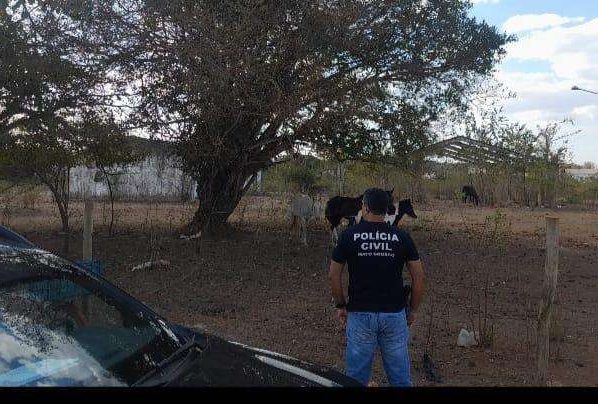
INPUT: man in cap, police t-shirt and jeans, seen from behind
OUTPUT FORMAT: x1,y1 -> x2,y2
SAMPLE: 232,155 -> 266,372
329,188 -> 424,386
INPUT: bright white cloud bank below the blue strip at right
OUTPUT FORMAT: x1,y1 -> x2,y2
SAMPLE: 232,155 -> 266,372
496,14 -> 598,162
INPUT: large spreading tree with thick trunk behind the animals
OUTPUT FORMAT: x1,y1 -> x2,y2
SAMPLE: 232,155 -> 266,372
54,0 -> 510,229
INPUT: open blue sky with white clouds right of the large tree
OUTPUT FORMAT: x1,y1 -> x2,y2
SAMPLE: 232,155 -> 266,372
472,0 -> 598,164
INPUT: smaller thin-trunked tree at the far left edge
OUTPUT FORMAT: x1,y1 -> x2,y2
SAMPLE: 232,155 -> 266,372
0,1 -> 93,237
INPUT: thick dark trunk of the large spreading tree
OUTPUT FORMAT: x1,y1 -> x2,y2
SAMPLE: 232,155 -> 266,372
189,167 -> 252,234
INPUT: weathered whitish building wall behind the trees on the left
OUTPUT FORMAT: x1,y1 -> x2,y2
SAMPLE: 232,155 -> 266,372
70,155 -> 197,201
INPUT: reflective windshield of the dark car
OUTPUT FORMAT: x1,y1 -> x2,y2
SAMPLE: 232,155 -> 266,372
0,252 -> 182,386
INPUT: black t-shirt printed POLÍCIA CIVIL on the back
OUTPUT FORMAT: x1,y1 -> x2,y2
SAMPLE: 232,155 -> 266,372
332,220 -> 419,313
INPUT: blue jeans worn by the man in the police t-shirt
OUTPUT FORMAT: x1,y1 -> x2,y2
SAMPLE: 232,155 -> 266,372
346,310 -> 411,387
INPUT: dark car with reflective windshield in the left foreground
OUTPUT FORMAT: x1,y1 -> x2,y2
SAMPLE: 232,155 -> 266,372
0,226 -> 358,387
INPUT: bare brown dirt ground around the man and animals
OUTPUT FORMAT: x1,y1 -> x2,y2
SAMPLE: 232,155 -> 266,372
4,197 -> 598,386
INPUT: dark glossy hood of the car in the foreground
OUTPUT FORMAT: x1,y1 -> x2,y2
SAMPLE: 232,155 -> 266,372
162,336 -> 360,387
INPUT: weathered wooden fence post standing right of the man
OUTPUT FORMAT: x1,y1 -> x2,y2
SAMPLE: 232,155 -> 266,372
536,216 -> 559,385
